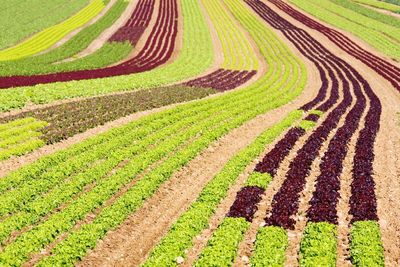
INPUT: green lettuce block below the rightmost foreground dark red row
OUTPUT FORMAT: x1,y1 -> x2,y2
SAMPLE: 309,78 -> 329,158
350,221 -> 385,267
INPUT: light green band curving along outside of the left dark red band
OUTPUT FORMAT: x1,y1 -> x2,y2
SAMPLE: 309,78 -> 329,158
0,0 -> 214,111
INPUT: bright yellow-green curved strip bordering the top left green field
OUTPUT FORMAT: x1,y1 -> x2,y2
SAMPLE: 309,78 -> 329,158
0,0 -> 105,61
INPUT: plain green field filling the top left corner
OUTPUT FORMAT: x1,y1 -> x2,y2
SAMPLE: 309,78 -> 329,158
0,0 -> 89,49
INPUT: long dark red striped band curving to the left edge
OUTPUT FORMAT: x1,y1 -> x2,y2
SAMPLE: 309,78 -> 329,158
0,0 -> 178,88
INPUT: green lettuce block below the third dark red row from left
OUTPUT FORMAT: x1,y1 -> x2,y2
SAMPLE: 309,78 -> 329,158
300,222 -> 337,267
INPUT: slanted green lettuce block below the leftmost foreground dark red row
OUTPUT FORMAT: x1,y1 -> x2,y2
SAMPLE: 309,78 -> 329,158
194,217 -> 250,267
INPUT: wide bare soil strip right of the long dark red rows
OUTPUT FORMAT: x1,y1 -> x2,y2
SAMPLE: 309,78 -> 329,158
264,1 -> 400,266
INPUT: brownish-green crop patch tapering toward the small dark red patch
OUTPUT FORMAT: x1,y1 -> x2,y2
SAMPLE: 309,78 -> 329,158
0,86 -> 217,144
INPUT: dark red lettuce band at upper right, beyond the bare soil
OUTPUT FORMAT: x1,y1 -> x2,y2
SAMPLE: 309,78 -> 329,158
268,0 -> 400,91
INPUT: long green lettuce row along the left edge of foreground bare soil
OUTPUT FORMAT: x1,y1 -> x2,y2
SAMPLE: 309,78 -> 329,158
36,107 -> 300,266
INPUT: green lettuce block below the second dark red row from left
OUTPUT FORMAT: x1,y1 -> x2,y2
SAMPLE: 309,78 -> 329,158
250,226 -> 289,267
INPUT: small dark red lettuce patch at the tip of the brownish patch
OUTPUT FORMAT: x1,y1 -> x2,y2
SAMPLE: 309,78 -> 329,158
183,69 -> 257,91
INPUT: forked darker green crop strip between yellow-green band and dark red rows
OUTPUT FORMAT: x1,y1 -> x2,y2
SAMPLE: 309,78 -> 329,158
0,0 -> 132,76
